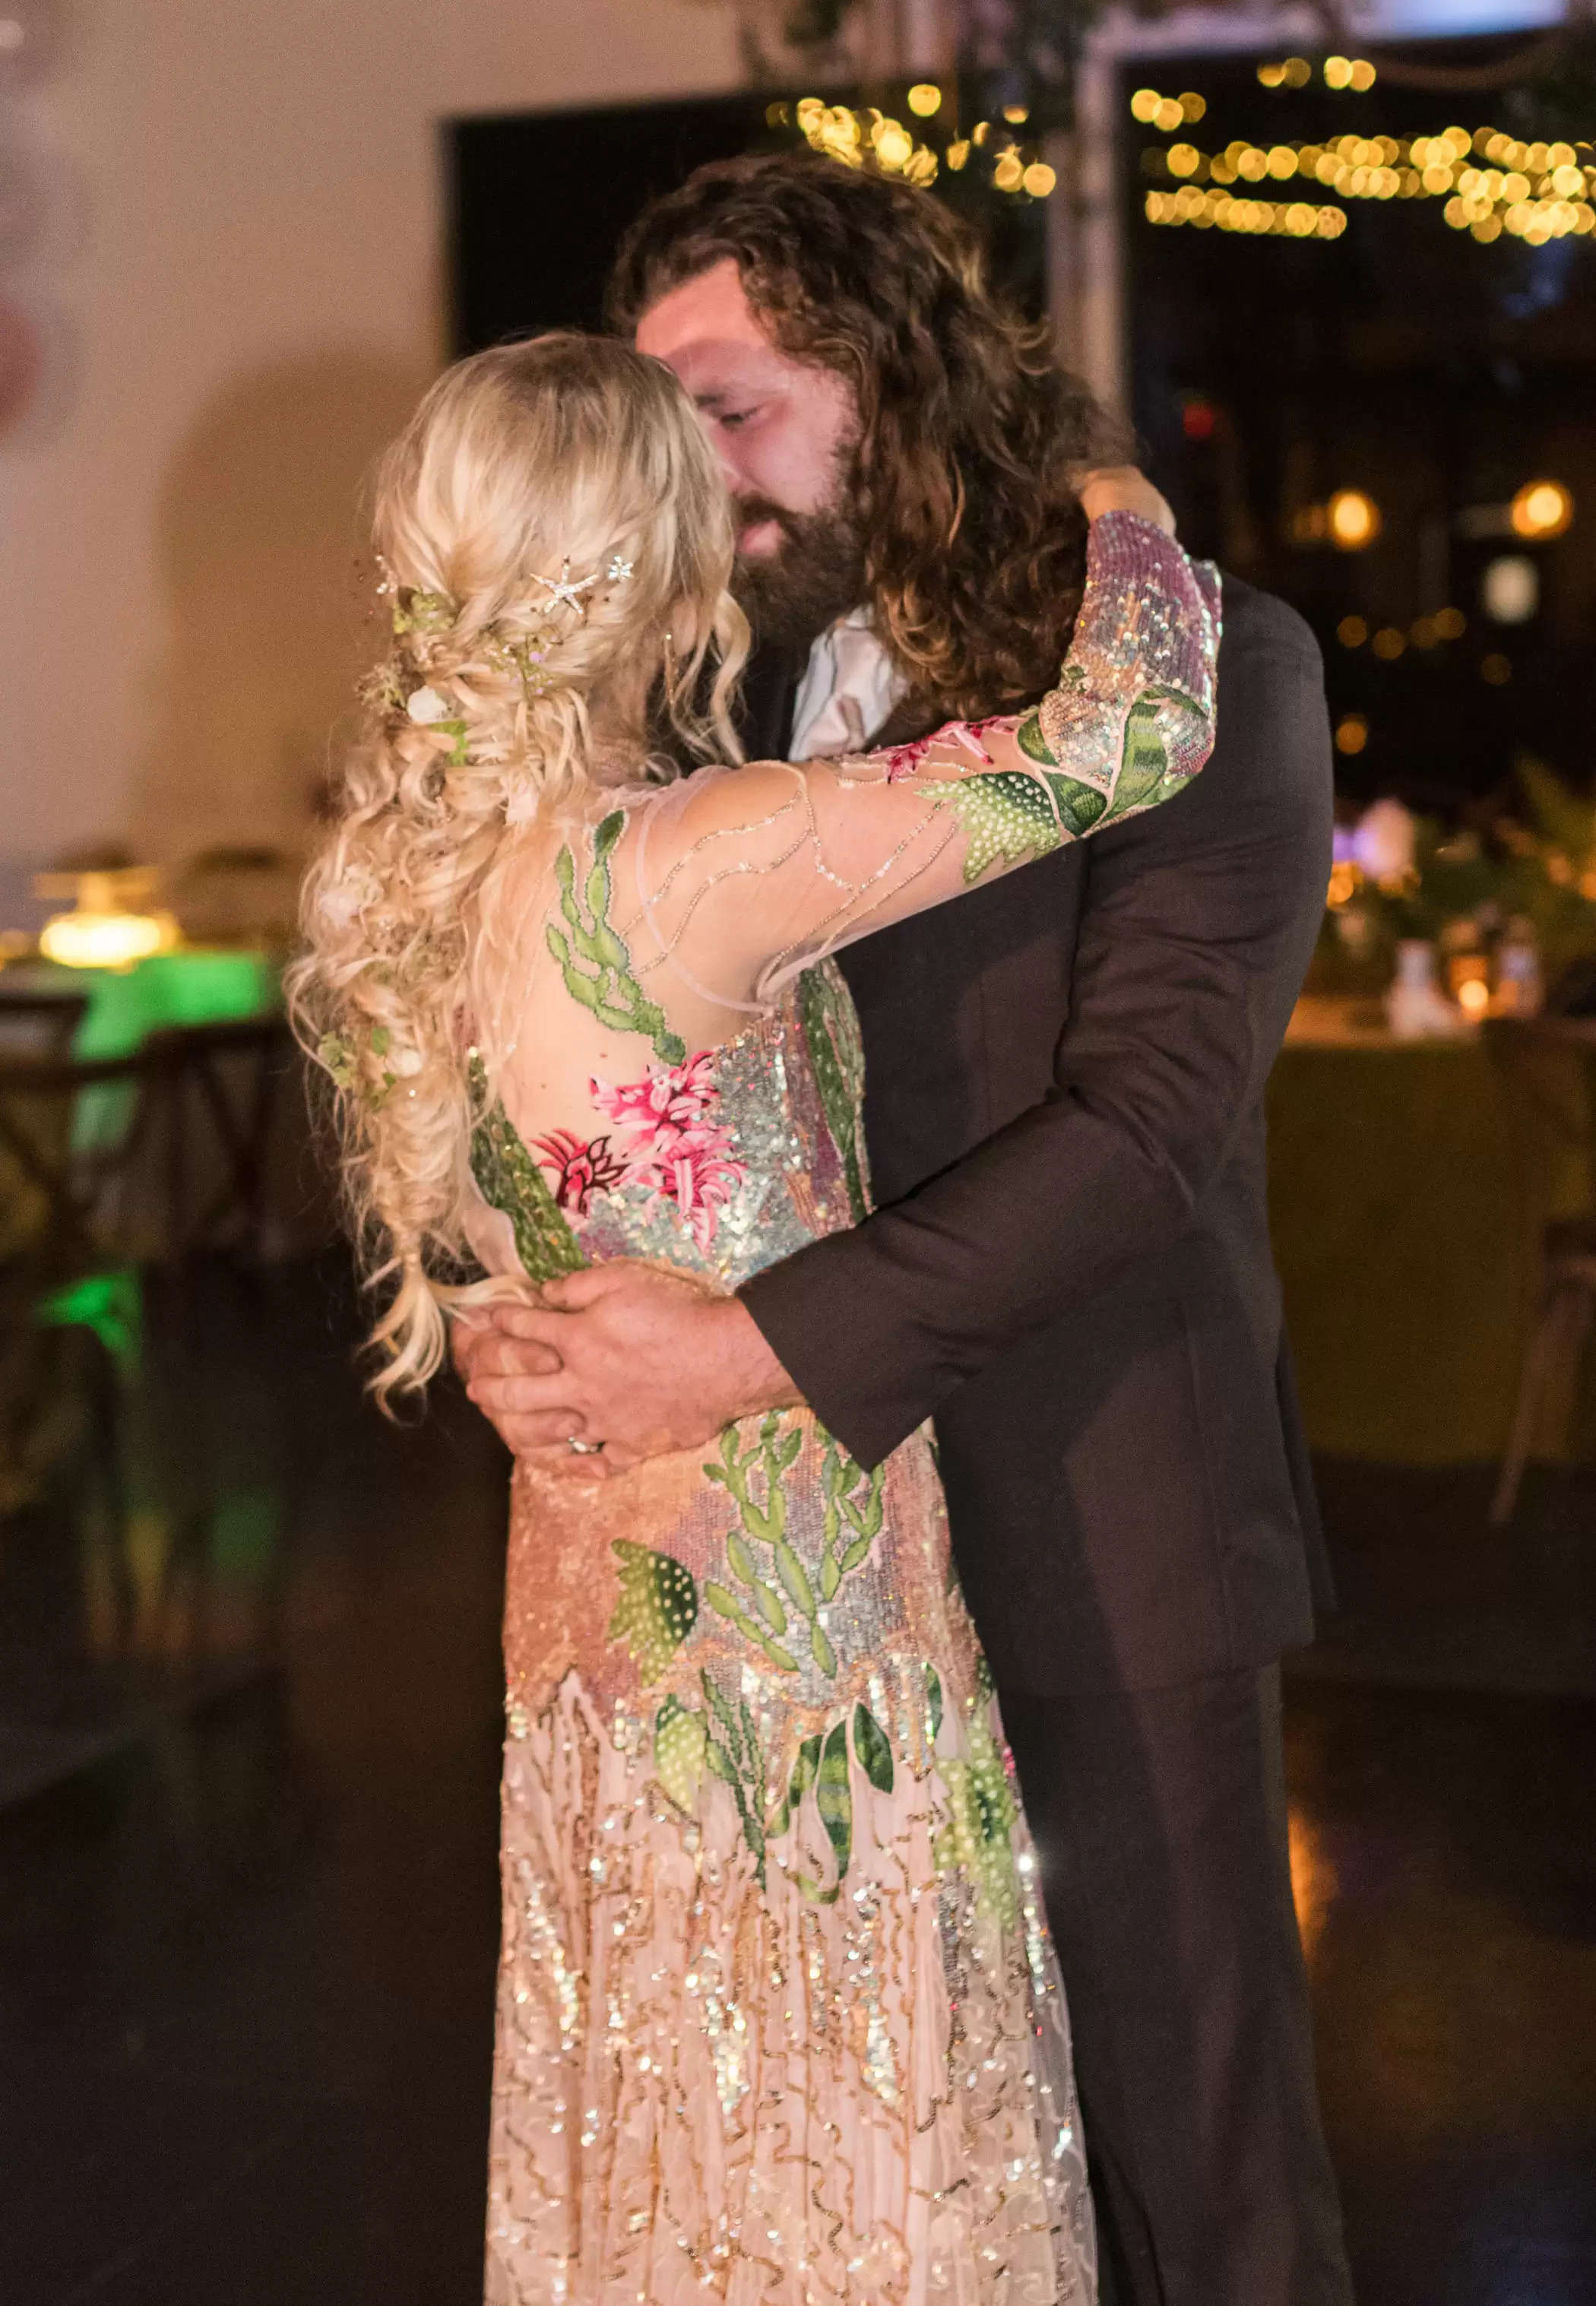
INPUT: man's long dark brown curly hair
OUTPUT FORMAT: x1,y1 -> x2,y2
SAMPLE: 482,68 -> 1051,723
609,152 -> 1130,715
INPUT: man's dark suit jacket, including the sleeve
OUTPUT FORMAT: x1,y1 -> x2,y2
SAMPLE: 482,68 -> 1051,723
743,579 -> 1331,1695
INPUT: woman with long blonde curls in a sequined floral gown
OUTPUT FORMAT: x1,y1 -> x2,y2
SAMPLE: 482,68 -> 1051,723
293,334 -> 1218,2306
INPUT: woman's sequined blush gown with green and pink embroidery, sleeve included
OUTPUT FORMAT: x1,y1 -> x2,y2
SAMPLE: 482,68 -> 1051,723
473,515 -> 1218,2306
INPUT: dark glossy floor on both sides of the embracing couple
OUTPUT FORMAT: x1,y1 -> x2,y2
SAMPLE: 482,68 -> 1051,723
0,1271 -> 1596,2306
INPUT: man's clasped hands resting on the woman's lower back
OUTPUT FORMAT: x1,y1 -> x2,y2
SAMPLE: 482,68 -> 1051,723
454,1259 -> 800,1481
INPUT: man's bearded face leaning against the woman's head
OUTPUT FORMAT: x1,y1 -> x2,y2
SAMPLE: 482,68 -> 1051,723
637,258 -> 865,643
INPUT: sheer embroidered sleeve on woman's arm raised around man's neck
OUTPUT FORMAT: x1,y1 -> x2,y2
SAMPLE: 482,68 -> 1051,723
635,512 -> 1220,1008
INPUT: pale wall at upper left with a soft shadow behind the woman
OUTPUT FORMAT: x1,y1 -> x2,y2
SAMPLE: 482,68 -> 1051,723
0,0 -> 738,927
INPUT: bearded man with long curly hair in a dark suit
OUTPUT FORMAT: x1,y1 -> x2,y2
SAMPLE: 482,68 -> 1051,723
459,157 -> 1351,2306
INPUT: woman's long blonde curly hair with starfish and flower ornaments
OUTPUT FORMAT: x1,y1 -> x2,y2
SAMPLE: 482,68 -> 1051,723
288,332 -> 747,1407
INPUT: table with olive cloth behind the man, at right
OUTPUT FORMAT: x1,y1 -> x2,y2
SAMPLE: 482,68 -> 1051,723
1268,999 -> 1589,1465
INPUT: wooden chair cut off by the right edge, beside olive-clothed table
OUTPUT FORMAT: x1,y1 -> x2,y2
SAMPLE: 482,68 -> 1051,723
1487,1017 -> 1596,1529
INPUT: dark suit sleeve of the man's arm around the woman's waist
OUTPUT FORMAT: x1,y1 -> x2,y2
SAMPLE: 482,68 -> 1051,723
740,597 -> 1331,1467
